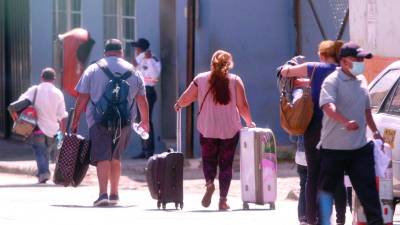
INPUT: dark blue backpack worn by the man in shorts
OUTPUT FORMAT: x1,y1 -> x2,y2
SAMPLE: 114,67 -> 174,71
92,60 -> 134,132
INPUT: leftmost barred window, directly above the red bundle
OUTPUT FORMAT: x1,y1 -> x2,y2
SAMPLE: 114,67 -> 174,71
54,0 -> 82,39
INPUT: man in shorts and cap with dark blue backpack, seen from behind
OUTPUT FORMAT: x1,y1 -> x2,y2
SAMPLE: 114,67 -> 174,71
72,39 -> 149,206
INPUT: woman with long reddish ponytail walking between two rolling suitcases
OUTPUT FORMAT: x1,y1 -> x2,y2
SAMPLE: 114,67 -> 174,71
174,50 -> 255,210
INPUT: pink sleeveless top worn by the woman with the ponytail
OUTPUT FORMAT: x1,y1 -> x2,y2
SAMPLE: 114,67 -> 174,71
194,72 -> 242,139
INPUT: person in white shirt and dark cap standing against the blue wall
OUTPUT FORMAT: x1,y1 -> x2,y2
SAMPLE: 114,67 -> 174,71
131,38 -> 161,159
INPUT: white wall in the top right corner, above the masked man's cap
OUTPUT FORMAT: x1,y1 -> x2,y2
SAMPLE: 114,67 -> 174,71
349,0 -> 400,57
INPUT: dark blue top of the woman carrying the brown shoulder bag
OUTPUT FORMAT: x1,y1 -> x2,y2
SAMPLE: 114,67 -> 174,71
307,62 -> 336,121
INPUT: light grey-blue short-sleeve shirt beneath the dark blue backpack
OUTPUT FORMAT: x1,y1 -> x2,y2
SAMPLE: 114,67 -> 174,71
75,56 -> 146,128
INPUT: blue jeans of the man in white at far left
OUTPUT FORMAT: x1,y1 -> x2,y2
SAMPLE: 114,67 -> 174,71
32,134 -> 53,176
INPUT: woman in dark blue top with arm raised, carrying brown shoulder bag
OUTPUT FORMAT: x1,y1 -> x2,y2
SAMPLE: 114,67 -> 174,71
281,40 -> 346,224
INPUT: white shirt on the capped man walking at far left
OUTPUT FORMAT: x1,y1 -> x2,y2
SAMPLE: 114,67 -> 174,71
19,82 -> 68,137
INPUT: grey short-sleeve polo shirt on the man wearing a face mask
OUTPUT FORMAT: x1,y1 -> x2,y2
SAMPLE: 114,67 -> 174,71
319,68 -> 371,150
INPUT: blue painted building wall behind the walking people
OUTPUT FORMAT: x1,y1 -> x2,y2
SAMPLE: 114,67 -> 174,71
27,0 -> 348,156
